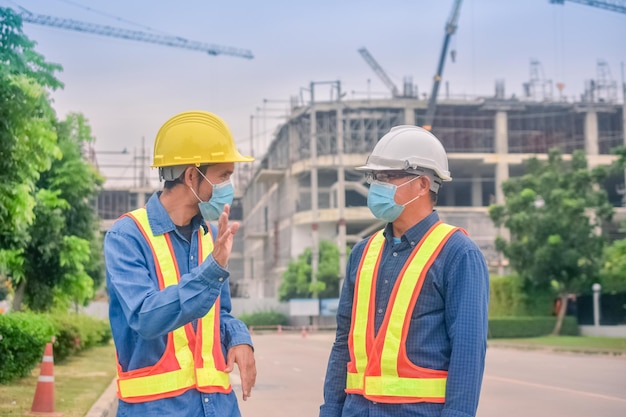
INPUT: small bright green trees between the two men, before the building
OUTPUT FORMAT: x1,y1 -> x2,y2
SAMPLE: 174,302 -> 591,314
278,240 -> 346,301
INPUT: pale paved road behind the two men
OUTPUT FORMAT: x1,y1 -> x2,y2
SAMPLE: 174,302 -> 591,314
233,332 -> 626,417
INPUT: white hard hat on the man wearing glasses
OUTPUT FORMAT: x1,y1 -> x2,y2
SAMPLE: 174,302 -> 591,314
355,125 -> 452,181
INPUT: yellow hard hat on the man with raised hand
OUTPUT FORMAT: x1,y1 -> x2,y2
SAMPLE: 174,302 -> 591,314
152,110 -> 254,168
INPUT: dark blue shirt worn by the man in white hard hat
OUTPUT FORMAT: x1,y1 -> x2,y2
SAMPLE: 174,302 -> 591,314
320,211 -> 489,417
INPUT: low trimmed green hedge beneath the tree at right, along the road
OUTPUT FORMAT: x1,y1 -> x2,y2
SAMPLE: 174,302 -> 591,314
488,316 -> 578,339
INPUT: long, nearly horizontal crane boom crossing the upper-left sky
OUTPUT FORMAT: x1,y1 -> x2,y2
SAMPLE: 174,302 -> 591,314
15,10 -> 254,59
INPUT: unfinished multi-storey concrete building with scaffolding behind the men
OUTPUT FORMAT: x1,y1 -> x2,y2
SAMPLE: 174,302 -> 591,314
236,82 -> 626,298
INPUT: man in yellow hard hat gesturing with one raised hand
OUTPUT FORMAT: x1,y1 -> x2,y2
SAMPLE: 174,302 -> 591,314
104,111 -> 256,417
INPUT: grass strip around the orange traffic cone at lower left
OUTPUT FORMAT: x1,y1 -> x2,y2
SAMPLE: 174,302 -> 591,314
0,344 -> 115,417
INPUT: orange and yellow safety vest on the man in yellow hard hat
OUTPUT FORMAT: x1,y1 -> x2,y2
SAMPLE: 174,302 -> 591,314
117,208 -> 232,403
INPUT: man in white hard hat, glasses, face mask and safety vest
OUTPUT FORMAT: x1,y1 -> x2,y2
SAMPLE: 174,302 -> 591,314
320,126 -> 489,417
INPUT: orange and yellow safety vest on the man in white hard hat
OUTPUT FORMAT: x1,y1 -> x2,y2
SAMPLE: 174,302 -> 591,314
346,222 -> 462,403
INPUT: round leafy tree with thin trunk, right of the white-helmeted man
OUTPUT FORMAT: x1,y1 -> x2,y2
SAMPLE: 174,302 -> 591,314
489,149 -> 613,334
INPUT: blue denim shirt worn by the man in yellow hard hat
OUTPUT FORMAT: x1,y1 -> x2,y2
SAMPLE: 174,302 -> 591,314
104,192 -> 252,417
